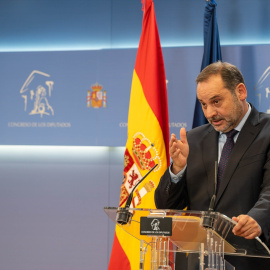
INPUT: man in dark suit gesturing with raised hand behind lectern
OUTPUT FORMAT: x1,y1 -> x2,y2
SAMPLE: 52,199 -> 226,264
155,62 -> 270,270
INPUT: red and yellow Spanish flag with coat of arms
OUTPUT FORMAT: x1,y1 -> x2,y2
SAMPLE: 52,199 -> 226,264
109,0 -> 169,270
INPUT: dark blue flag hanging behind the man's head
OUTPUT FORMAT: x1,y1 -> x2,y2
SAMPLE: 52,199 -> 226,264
192,0 -> 222,128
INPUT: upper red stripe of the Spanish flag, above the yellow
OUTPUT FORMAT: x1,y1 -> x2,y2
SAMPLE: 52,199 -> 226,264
135,0 -> 170,164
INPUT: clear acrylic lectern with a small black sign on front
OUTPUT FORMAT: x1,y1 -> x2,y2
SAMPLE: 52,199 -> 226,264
104,207 -> 270,270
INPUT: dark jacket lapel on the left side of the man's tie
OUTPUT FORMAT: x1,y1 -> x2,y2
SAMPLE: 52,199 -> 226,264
202,126 -> 219,198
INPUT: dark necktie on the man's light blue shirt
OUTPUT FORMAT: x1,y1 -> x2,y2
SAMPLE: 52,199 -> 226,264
217,129 -> 238,191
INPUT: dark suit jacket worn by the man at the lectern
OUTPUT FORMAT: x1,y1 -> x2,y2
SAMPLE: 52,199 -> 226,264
155,106 -> 270,269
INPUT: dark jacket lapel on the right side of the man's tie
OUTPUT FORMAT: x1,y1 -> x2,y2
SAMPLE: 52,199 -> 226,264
216,107 -> 261,204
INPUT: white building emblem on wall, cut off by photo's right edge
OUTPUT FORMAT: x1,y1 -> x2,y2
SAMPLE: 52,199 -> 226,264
254,66 -> 270,114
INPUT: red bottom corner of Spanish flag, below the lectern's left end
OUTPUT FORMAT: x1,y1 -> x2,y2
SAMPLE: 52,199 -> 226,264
108,234 -> 131,270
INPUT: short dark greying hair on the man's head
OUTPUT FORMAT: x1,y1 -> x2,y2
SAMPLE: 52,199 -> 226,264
196,61 -> 245,93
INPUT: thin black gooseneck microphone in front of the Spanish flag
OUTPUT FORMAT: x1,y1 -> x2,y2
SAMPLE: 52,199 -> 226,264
116,164 -> 158,225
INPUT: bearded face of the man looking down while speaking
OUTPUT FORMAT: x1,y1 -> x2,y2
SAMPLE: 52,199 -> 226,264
197,75 -> 245,132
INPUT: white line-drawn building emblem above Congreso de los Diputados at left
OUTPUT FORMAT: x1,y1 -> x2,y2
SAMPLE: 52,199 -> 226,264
20,70 -> 54,117
